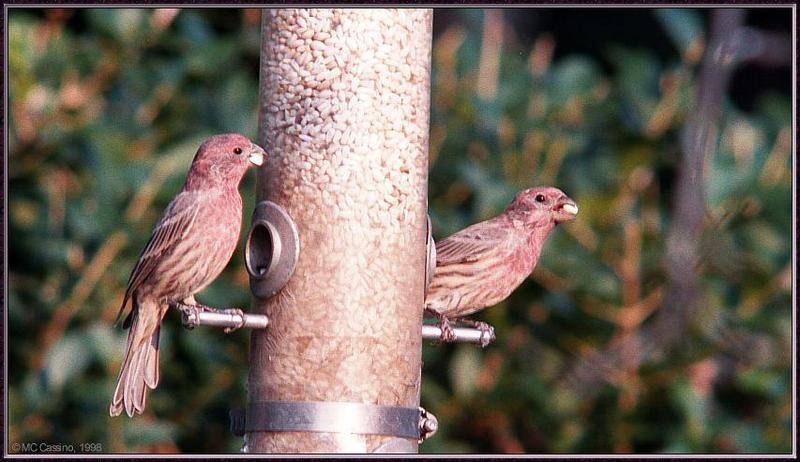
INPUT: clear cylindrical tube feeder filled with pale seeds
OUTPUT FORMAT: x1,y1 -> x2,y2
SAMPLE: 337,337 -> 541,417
245,9 -> 432,453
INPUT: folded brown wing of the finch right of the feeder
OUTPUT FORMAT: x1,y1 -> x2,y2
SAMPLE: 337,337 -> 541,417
436,221 -> 509,266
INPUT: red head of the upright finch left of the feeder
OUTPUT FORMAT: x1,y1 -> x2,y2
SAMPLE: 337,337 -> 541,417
185,133 -> 266,189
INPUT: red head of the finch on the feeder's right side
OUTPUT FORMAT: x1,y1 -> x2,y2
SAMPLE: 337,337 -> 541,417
506,186 -> 578,225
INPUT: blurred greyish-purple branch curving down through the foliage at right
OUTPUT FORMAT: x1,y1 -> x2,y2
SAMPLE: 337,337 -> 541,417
565,9 -> 745,393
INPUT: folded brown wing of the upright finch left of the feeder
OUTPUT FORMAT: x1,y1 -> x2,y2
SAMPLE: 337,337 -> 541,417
117,192 -> 200,324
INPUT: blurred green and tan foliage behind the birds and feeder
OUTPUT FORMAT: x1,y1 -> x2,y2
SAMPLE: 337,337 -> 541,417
5,8 -> 793,453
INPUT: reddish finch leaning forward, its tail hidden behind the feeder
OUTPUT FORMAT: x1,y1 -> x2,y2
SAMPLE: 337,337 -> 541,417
425,187 -> 578,346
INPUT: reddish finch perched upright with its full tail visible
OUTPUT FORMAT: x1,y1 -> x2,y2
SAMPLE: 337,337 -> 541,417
109,134 -> 265,417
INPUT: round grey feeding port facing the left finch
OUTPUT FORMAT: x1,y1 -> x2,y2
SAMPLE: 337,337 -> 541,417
244,201 -> 300,299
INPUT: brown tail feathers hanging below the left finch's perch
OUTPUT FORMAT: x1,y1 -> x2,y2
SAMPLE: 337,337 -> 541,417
109,306 -> 161,417
